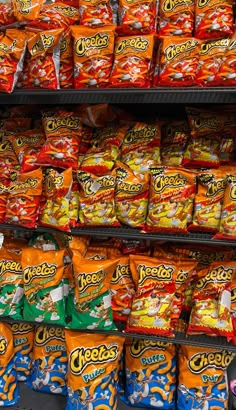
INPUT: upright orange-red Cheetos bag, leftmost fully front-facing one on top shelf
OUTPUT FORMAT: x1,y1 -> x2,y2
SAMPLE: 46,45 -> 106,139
71,25 -> 115,88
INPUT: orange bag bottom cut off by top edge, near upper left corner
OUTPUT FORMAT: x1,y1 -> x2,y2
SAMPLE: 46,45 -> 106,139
12,0 -> 44,23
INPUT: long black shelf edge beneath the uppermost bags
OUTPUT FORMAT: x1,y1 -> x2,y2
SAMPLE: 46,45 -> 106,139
0,87 -> 236,104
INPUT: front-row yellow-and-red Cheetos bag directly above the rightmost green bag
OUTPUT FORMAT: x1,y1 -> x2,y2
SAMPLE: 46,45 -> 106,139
77,171 -> 119,226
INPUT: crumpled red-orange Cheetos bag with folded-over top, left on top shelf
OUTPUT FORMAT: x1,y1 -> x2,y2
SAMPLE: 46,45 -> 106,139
28,30 -> 62,90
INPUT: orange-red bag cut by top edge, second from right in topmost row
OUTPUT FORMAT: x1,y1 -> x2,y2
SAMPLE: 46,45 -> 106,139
158,0 -> 194,37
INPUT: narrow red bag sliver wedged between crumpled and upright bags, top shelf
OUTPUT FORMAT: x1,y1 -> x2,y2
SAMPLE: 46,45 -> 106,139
60,30 -> 74,88
